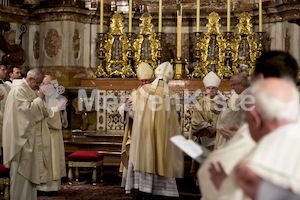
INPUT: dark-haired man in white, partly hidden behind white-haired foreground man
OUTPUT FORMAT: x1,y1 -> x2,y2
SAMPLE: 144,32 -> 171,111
197,51 -> 298,200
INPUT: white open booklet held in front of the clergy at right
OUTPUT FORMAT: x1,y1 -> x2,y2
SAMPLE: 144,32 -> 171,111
170,135 -> 210,163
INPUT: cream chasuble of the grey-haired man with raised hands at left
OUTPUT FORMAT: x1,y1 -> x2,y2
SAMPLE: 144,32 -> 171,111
3,80 -> 51,184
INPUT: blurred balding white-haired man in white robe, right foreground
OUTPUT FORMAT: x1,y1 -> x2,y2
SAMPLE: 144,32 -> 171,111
234,78 -> 300,200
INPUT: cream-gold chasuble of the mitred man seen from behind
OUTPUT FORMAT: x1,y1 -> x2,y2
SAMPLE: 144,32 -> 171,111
129,81 -> 184,178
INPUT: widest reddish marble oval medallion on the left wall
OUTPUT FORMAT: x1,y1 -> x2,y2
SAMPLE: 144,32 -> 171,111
45,29 -> 62,58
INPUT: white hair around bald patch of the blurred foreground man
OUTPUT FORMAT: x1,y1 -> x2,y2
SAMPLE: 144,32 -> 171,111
249,81 -> 300,122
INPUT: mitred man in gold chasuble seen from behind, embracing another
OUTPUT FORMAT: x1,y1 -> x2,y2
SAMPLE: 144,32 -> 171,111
125,62 -> 184,199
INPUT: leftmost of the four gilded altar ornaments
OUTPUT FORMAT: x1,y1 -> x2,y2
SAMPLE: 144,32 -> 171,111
104,12 -> 135,78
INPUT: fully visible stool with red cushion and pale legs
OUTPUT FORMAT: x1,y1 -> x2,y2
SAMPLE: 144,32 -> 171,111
67,151 -> 104,185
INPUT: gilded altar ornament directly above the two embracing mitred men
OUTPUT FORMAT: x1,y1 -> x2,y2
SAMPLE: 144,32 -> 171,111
133,12 -> 160,69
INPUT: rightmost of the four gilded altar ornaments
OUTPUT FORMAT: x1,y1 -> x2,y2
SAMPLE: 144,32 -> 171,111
231,12 -> 258,75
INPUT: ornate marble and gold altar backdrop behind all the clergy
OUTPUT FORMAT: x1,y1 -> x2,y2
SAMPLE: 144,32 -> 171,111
0,0 -> 300,198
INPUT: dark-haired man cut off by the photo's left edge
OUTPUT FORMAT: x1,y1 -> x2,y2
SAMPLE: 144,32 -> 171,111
0,61 -> 10,163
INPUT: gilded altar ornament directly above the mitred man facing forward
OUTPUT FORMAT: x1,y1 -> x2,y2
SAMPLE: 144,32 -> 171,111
199,12 -> 226,78
